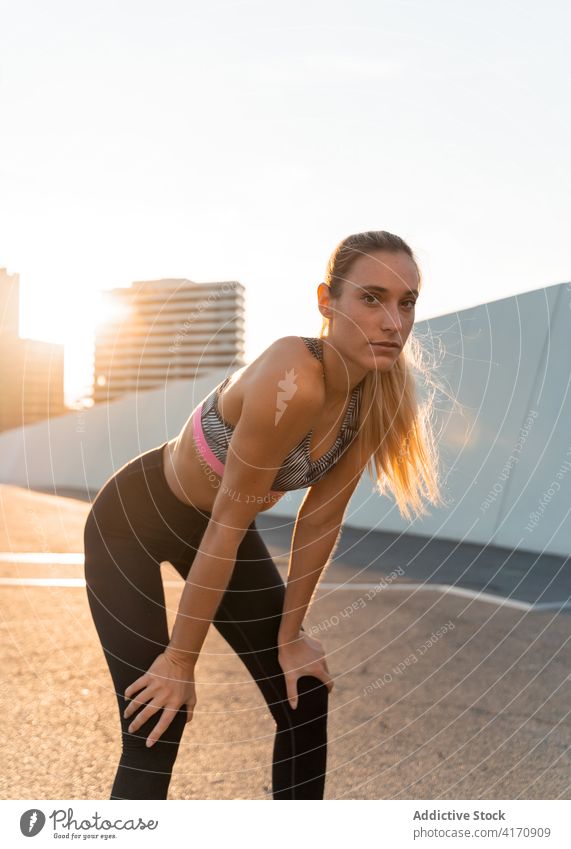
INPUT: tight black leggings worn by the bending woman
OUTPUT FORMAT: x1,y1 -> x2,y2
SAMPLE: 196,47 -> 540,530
84,443 -> 328,799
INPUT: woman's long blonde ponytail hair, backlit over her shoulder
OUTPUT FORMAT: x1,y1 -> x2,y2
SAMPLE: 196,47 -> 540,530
319,230 -> 445,519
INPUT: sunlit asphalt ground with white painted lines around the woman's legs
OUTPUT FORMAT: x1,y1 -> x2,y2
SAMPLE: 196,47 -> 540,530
0,485 -> 571,800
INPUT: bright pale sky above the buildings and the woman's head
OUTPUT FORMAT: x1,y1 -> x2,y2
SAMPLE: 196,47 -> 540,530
0,0 -> 571,402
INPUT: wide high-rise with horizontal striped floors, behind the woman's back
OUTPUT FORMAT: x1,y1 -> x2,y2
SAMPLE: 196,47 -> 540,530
93,279 -> 245,403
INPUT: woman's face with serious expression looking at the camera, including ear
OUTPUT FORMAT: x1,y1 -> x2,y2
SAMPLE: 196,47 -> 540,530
318,251 -> 420,371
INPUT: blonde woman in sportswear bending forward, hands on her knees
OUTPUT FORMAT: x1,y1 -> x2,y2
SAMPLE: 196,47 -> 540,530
85,231 -> 441,799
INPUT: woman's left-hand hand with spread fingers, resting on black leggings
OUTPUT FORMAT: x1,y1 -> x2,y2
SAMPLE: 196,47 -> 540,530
123,650 -> 196,746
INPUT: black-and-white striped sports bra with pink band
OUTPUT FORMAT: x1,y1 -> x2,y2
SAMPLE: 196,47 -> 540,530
192,336 -> 363,497
